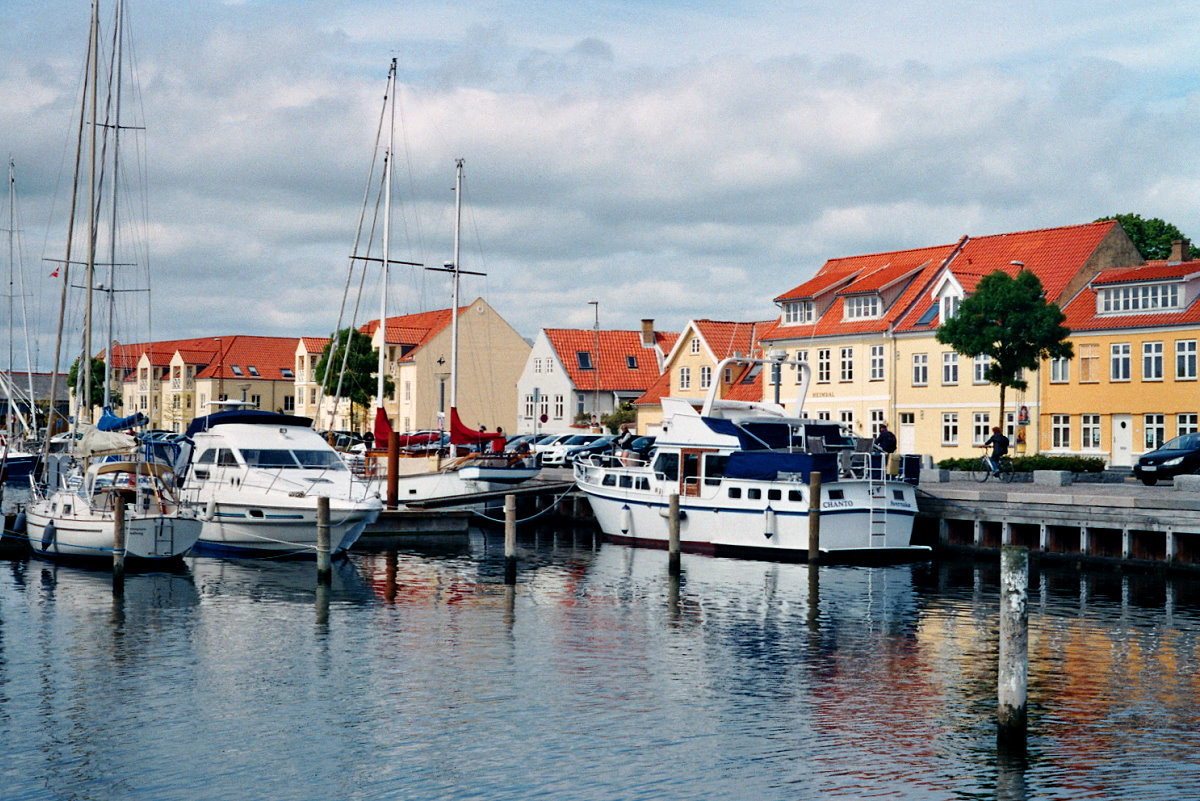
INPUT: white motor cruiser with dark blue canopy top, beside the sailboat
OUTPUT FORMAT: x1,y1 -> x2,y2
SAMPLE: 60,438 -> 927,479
181,404 -> 383,556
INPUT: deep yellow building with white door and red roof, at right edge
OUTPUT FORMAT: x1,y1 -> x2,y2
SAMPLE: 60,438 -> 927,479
1039,242 -> 1200,466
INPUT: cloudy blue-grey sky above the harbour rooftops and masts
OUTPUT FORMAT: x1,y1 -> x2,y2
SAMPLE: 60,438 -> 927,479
0,0 -> 1200,368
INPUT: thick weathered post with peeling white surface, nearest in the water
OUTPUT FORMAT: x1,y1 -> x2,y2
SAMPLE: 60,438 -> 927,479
996,546 -> 1030,753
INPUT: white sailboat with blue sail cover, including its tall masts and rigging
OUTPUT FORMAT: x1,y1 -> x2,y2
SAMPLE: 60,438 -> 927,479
25,0 -> 200,562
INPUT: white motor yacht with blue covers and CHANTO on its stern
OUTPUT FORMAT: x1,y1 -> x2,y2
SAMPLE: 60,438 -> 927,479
575,359 -> 930,561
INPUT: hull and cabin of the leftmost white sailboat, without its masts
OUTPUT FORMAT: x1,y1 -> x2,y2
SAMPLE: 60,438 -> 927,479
25,462 -> 200,561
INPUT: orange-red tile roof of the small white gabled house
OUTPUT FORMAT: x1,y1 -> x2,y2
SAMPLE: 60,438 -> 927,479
545,329 -> 678,391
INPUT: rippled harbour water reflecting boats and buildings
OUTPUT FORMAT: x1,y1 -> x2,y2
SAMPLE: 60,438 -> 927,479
0,531 -> 1200,801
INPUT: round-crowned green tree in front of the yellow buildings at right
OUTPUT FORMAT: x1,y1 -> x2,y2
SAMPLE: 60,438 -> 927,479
937,270 -> 1075,426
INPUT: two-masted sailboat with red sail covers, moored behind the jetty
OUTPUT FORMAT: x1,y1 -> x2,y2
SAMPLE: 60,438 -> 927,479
345,59 -> 540,505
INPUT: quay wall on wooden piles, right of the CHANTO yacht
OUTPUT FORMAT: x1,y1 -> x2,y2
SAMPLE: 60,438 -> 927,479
914,478 -> 1200,571
